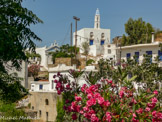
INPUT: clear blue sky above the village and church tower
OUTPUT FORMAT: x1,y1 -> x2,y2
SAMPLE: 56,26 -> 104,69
23,0 -> 162,47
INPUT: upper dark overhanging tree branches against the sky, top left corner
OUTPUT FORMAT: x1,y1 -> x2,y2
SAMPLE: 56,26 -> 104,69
0,0 -> 43,71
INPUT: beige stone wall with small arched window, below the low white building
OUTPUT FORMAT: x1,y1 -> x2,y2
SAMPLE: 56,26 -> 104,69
29,92 -> 60,122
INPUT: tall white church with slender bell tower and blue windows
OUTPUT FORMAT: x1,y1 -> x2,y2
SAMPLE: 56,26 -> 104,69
73,9 -> 114,57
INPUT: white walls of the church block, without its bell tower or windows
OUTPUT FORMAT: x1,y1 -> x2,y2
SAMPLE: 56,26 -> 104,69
73,28 -> 110,56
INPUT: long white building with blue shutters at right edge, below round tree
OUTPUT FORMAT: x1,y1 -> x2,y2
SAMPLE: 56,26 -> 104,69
118,42 -> 162,66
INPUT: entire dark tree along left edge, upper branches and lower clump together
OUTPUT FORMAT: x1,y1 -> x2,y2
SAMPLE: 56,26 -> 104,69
0,0 -> 43,102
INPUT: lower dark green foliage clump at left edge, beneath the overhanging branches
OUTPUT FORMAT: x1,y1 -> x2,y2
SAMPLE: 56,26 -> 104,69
0,72 -> 28,103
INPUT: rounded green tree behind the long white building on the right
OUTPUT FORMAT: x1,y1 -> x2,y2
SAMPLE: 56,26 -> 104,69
122,18 -> 154,45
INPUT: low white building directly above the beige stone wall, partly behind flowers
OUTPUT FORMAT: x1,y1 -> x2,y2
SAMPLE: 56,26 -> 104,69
30,64 -> 97,92
